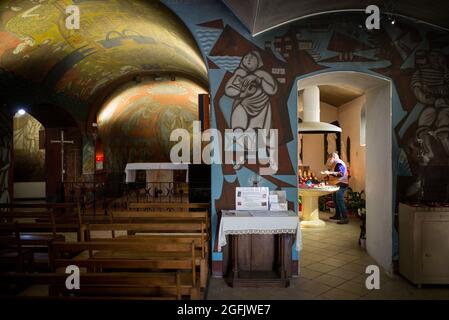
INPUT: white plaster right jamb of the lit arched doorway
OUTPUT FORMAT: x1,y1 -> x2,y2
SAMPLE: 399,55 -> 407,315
366,84 -> 393,273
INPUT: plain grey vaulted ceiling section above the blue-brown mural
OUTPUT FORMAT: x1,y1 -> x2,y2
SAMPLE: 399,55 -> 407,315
223,0 -> 449,35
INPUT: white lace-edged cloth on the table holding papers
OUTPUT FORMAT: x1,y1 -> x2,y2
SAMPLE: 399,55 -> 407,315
218,210 -> 302,251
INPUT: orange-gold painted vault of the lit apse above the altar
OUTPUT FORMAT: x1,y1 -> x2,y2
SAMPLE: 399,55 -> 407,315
97,77 -> 206,172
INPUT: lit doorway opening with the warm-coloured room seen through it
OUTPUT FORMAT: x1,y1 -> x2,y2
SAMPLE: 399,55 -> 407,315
297,71 -> 393,273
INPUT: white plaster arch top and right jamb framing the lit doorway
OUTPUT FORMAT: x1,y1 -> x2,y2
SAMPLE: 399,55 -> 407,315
297,71 -> 393,272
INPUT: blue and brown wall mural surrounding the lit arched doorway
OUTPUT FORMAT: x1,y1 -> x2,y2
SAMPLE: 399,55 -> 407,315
165,0 -> 449,268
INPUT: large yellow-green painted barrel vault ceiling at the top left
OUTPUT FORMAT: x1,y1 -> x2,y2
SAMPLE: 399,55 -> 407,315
0,0 -> 207,100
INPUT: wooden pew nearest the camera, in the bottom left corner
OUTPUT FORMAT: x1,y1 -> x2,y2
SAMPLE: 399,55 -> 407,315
0,271 -> 182,300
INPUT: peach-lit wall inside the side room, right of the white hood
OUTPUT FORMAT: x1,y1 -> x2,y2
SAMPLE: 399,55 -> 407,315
338,96 -> 366,192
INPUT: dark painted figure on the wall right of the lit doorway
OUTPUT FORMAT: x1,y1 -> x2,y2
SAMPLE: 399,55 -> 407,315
400,48 -> 449,201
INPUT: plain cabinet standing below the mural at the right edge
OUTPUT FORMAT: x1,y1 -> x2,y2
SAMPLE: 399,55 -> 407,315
399,204 -> 449,285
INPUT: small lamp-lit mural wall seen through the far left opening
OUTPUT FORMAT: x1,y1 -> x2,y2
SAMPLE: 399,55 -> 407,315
14,113 -> 45,182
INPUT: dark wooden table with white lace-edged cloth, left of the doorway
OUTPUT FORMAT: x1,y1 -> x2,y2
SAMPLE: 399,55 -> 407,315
217,210 -> 301,287
